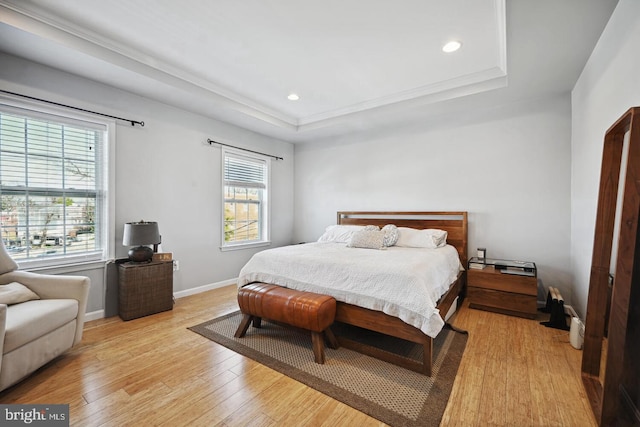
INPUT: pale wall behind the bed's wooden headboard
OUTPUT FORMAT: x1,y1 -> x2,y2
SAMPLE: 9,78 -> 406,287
295,93 -> 571,298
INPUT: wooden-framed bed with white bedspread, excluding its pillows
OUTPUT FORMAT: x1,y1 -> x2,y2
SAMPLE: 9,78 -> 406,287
238,211 -> 467,376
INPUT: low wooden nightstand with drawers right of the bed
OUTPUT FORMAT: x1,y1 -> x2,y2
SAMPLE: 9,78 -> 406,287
467,257 -> 538,319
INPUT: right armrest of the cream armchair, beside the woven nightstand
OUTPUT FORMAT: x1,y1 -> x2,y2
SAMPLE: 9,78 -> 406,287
0,270 -> 91,345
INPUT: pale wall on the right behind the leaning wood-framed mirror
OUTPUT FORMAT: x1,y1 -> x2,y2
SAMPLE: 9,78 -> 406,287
571,0 -> 640,319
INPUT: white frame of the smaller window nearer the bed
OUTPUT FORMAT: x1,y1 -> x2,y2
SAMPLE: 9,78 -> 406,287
220,147 -> 271,251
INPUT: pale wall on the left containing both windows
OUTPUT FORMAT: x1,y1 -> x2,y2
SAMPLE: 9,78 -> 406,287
0,54 -> 294,312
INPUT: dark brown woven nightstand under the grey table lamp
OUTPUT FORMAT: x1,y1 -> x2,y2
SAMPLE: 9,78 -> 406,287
118,260 -> 173,320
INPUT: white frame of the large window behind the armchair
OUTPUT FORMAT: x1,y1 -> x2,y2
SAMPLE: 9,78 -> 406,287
0,94 -> 116,270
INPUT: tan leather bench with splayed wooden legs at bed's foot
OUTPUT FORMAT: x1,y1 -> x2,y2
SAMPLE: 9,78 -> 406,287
235,283 -> 338,364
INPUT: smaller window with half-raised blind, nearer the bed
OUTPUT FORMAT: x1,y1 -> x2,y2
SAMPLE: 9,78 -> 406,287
222,149 -> 269,249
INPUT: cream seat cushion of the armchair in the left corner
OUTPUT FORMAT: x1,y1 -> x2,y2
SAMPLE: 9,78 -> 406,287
4,299 -> 78,353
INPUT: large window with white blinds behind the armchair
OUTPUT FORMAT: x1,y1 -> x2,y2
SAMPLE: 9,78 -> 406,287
0,104 -> 109,265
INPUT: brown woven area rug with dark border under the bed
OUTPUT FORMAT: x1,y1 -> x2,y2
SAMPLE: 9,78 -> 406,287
189,311 -> 467,427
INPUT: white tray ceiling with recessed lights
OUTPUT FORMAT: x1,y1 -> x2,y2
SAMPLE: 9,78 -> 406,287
0,0 -> 617,142
